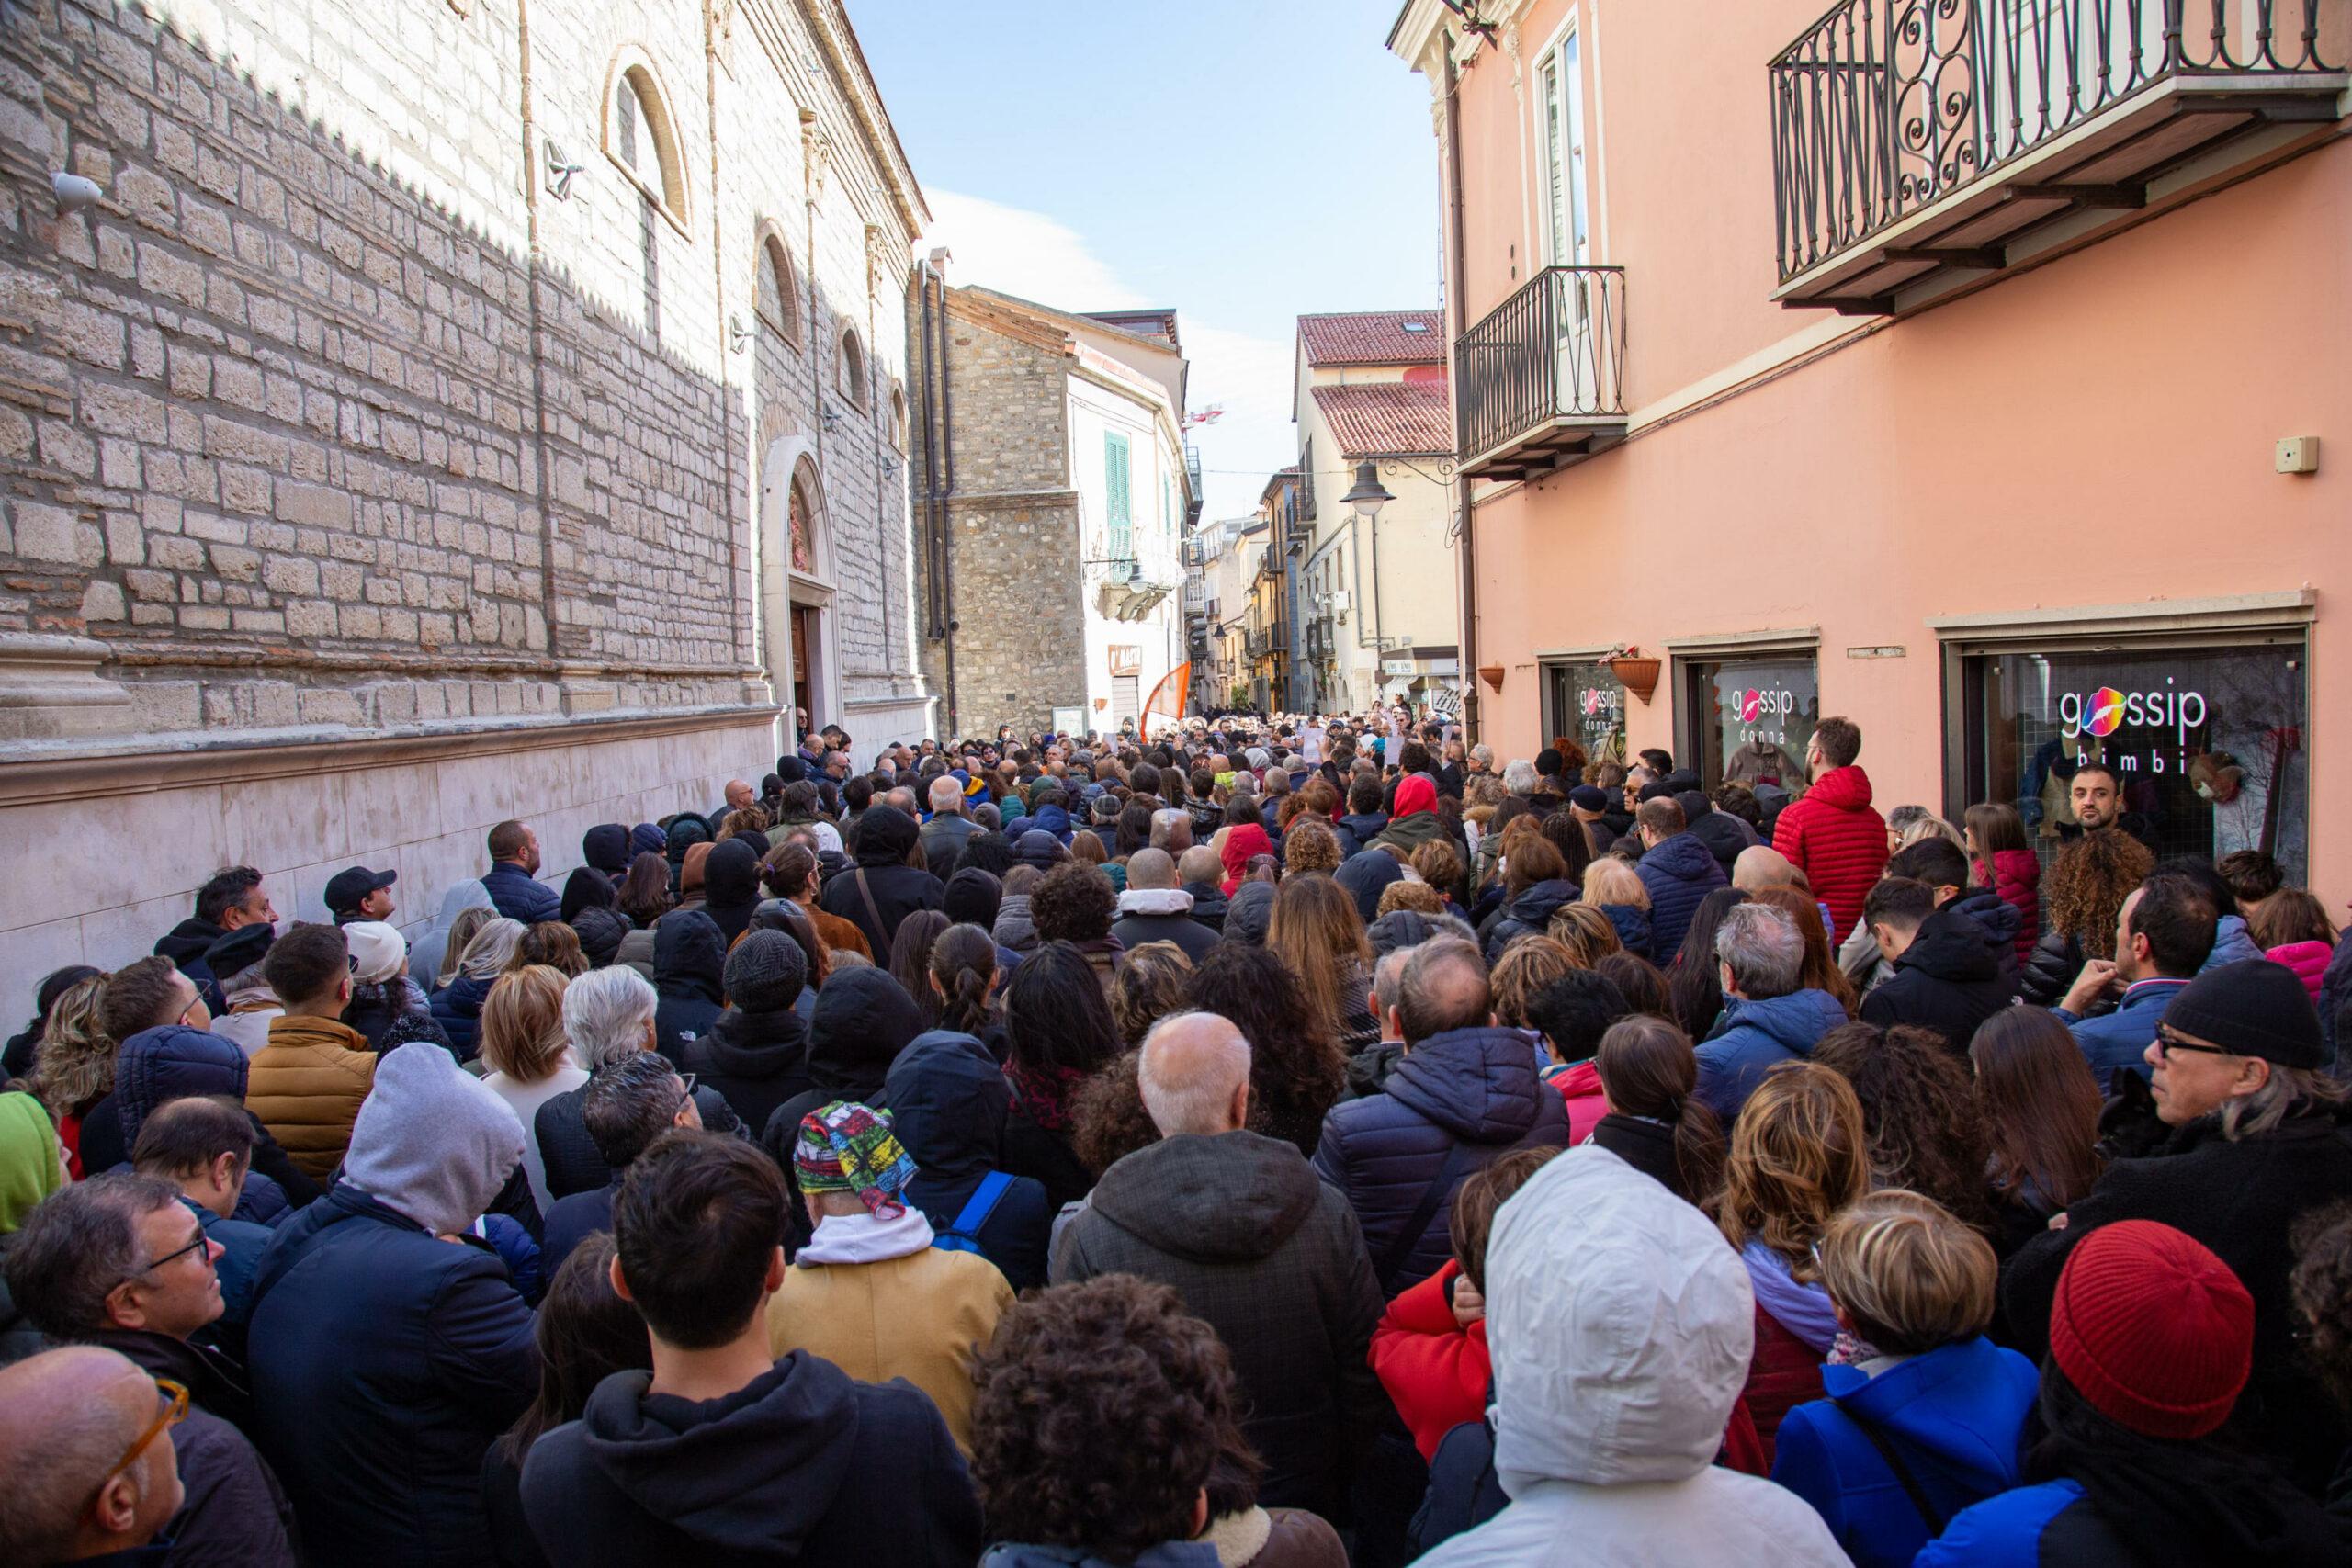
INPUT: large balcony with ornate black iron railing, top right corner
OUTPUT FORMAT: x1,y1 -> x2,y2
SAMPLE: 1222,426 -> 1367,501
1771,0 -> 2352,315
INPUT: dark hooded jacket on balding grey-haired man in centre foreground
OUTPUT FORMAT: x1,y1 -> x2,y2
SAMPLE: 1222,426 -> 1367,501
1054,1134 -> 1387,1517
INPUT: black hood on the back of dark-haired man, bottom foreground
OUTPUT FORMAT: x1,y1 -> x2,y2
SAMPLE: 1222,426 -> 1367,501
581,1349 -> 868,1561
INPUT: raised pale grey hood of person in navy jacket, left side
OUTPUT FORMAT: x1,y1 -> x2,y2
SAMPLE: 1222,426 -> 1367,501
344,1039 -> 522,1235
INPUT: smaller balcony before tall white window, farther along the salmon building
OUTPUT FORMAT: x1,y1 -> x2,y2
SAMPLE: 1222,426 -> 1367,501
1453,265 -> 1625,479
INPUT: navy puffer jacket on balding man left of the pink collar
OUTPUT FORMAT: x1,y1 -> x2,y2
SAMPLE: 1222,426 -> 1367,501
1315,1027 -> 1569,1298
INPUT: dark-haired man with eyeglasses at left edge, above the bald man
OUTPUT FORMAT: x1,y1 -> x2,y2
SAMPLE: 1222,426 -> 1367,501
0,1170 -> 294,1563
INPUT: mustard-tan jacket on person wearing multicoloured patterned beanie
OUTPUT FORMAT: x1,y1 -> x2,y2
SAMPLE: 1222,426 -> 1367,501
767,1246 -> 1013,1458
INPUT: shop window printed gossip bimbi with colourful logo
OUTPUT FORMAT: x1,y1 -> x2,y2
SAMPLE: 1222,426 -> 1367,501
1962,632 -> 2310,884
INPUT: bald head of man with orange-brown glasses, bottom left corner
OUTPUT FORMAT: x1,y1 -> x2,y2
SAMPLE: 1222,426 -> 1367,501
0,1345 -> 181,1563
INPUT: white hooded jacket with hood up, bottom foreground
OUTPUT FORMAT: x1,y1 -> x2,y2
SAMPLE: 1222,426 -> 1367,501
1420,1145 -> 1847,1568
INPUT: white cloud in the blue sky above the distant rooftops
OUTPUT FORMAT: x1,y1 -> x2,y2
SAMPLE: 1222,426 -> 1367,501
922,190 -> 1298,517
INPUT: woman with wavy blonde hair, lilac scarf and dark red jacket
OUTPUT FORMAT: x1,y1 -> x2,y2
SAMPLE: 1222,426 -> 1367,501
1714,1063 -> 1870,1460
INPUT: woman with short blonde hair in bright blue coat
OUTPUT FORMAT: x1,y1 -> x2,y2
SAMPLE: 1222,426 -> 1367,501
1771,1187 -> 2041,1568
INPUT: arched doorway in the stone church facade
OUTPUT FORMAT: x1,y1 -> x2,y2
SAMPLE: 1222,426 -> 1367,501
760,437 -> 842,750
